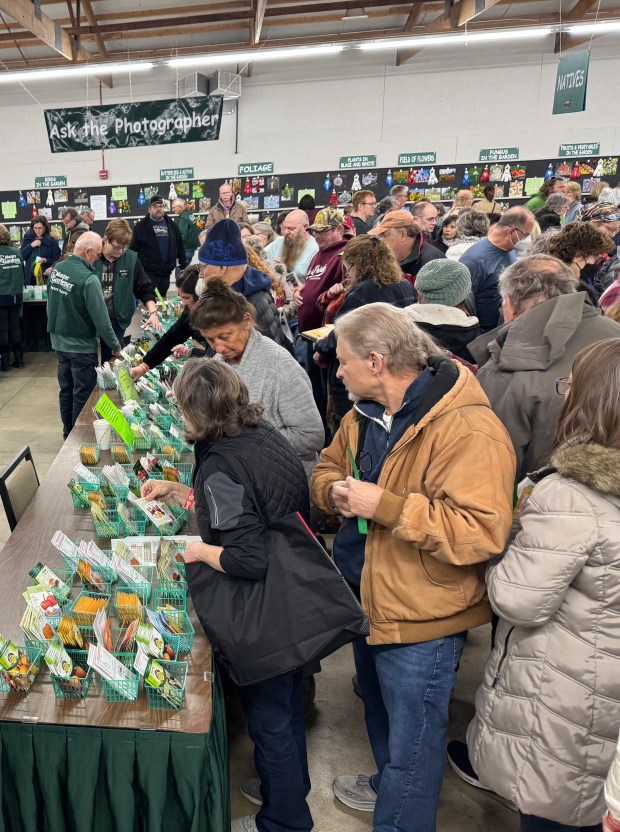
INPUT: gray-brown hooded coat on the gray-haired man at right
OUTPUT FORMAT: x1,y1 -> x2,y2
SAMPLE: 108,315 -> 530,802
468,292 -> 620,481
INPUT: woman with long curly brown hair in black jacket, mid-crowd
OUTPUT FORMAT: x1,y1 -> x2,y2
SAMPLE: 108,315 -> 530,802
315,234 -> 415,434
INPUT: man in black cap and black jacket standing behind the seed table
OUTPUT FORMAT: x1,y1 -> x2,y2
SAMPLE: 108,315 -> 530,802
130,194 -> 187,298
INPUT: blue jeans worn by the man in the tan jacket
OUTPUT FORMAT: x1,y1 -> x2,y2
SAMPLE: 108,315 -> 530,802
353,633 -> 467,832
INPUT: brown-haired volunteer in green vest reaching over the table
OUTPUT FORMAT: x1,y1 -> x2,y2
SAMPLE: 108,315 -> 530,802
95,219 -> 162,364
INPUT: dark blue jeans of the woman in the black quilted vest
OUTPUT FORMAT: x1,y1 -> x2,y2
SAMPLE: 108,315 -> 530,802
238,671 -> 313,832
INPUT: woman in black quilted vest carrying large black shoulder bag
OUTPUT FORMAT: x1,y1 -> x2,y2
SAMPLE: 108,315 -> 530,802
143,361 -> 312,832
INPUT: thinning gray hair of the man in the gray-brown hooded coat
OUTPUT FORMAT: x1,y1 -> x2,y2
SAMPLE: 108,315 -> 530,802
499,254 -> 577,315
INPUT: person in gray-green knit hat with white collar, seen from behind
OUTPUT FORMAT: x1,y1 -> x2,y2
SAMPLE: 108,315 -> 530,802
407,260 -> 480,362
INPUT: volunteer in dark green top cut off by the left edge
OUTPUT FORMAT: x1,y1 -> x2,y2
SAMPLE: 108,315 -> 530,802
0,225 -> 24,372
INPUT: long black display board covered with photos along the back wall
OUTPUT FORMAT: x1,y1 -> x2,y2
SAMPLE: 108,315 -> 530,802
0,156 -> 618,244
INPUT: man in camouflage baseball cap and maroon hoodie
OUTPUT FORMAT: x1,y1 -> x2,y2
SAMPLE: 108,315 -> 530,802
293,206 -> 347,436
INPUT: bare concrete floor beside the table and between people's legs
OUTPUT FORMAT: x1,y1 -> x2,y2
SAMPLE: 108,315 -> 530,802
0,353 -> 518,832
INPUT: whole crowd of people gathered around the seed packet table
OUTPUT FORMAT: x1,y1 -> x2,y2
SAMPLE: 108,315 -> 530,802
0,177 -> 620,832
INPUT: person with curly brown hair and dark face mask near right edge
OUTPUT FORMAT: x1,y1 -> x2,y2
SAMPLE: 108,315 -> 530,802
549,222 -> 613,306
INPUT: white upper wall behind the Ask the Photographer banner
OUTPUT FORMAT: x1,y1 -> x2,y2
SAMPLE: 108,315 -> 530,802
0,42 -> 620,190
